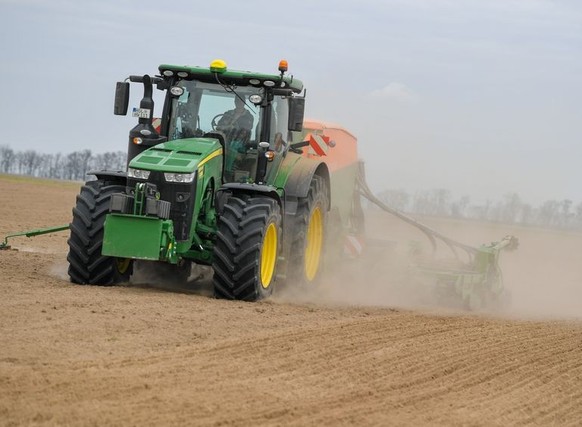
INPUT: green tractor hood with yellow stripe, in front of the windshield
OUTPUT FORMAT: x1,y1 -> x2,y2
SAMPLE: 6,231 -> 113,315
129,138 -> 222,173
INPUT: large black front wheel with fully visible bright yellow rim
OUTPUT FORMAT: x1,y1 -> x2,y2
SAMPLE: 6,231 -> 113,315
212,194 -> 281,301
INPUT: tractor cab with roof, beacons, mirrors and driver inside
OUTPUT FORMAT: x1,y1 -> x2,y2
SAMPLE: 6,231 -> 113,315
115,60 -> 305,183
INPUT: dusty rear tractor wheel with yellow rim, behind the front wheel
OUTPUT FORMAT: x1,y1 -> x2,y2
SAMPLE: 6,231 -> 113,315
289,175 -> 328,285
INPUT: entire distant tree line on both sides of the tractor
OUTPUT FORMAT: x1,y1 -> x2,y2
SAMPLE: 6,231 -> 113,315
0,145 -> 582,229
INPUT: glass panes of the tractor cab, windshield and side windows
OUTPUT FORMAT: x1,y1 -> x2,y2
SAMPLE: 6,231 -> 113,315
168,80 -> 288,182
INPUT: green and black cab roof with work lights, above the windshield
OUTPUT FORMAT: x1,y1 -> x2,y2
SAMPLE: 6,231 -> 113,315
158,64 -> 303,93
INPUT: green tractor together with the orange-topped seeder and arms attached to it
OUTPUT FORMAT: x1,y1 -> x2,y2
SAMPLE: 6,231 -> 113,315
0,60 -> 518,310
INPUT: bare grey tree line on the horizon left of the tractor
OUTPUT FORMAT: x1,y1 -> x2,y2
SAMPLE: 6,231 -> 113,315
0,145 -> 127,181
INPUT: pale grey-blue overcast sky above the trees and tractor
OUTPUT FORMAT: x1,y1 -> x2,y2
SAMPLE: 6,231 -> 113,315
0,0 -> 582,204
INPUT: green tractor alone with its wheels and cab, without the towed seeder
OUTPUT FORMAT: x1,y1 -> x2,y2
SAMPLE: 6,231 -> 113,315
67,60 -> 338,301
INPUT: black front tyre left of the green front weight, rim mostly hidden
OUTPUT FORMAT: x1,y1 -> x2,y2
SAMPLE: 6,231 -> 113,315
67,180 -> 133,286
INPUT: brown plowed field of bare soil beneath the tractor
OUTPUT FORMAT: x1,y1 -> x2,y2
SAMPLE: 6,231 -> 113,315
0,176 -> 582,426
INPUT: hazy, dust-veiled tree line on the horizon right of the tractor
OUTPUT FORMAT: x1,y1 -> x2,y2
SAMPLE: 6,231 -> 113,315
378,189 -> 582,229
